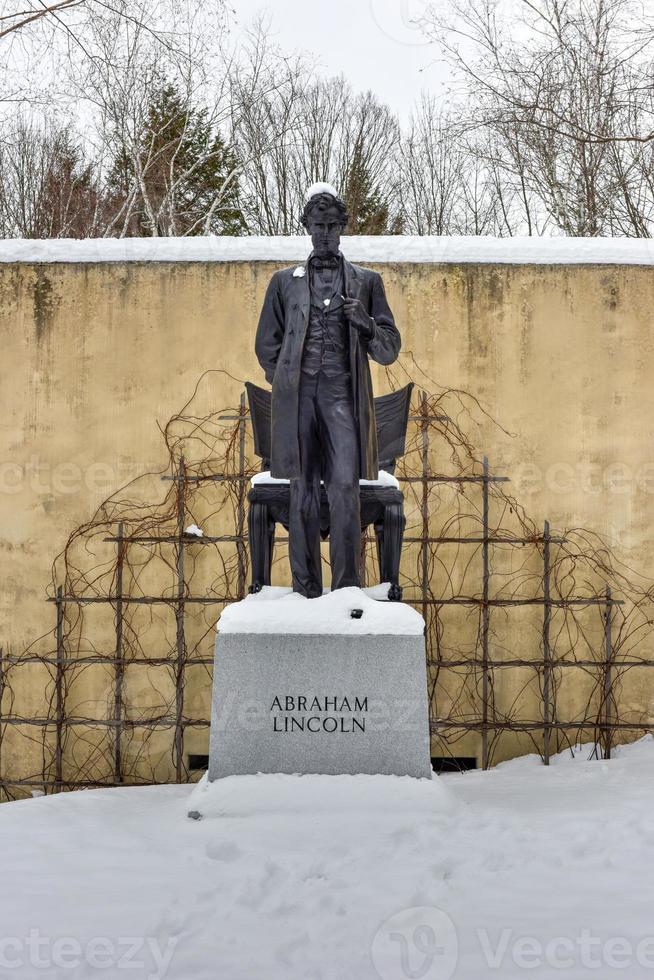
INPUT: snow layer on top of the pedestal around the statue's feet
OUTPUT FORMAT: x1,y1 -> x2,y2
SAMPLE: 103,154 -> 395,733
216,583 -> 425,636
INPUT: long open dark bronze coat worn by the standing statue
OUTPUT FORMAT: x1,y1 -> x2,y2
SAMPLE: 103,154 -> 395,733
255,259 -> 401,480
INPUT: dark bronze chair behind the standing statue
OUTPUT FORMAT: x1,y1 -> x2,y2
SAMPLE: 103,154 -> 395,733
245,381 -> 413,601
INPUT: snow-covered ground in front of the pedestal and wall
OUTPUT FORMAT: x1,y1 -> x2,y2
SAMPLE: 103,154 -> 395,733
0,736 -> 654,980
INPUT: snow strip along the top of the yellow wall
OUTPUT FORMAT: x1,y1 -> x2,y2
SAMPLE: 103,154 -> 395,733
0,235 -> 654,265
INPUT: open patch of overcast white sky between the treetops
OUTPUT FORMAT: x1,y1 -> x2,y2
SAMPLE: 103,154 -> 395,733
230,0 -> 449,118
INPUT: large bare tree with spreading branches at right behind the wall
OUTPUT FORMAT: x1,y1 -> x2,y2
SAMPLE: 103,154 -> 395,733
424,0 -> 654,235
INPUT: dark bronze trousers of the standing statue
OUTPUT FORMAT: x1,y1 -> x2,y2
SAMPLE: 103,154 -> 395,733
289,366 -> 361,598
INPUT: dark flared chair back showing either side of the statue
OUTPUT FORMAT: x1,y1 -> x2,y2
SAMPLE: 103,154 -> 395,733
245,381 -> 413,473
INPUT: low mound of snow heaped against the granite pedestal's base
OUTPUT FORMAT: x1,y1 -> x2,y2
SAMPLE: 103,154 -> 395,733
188,773 -> 457,819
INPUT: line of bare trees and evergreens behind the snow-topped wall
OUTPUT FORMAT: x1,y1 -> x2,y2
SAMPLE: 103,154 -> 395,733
7,0 -> 654,237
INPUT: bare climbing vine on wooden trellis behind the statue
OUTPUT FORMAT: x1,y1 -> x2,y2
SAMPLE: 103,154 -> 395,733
0,354 -> 654,798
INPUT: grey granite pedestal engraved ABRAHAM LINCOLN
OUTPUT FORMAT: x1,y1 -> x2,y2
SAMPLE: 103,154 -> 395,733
209,590 -> 431,780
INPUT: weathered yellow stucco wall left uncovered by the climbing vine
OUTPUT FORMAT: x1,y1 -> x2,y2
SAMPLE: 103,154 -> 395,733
0,261 -> 654,792
